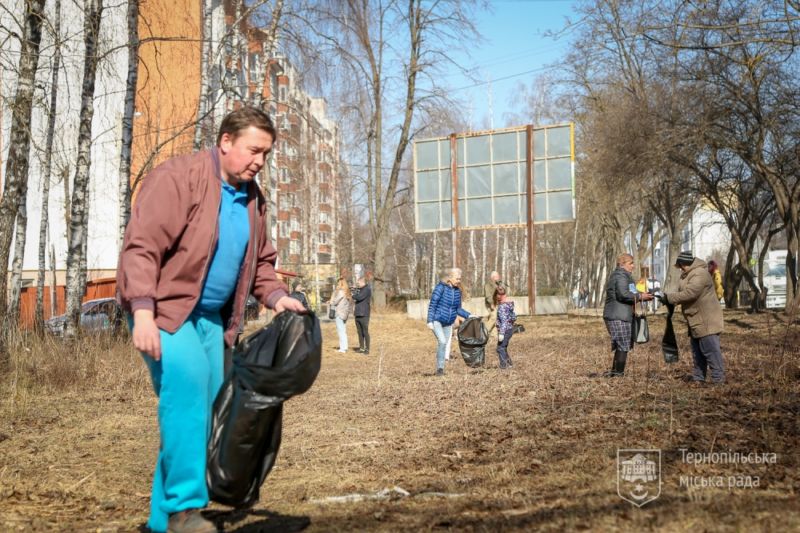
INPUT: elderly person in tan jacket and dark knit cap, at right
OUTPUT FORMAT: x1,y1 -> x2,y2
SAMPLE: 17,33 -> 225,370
656,251 -> 725,383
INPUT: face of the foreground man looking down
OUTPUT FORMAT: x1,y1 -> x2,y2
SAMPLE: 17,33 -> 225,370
219,126 -> 274,186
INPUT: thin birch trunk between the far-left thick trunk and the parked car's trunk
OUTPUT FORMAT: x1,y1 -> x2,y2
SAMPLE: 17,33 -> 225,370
33,0 -> 61,330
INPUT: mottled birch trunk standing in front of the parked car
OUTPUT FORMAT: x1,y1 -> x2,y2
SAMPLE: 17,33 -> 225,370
64,0 -> 103,337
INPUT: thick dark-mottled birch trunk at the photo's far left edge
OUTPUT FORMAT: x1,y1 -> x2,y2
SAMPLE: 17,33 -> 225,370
0,0 -> 45,358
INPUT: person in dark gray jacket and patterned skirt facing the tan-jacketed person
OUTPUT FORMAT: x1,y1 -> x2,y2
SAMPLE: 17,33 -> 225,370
603,254 -> 653,377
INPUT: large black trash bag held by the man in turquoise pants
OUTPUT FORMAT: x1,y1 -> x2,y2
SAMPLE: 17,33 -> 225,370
206,312 -> 322,507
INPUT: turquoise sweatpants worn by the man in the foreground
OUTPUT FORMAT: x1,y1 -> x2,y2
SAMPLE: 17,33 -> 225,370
134,310 -> 224,532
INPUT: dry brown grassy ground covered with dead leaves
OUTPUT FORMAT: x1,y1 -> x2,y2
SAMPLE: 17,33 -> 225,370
0,312 -> 800,532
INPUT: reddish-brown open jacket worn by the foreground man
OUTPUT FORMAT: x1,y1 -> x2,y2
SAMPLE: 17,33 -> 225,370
117,148 -> 287,346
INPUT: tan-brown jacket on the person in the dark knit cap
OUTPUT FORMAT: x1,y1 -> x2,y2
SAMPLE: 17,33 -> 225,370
667,258 -> 723,339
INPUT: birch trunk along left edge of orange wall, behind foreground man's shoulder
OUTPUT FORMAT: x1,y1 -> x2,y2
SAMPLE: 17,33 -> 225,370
117,0 -> 139,245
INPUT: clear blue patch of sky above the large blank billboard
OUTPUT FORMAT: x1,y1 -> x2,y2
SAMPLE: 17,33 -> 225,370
445,0 -> 576,129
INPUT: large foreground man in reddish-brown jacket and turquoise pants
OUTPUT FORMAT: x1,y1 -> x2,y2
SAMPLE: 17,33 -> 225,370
117,107 -> 304,533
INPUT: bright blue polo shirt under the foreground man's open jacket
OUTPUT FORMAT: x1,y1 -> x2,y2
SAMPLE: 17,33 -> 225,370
197,180 -> 250,312
